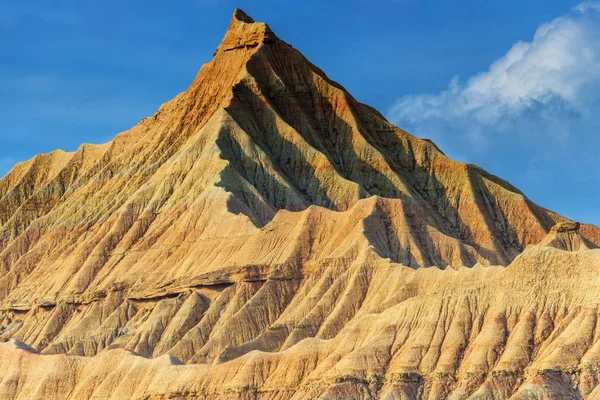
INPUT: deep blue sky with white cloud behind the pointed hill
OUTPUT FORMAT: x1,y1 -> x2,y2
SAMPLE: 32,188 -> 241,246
0,0 -> 600,225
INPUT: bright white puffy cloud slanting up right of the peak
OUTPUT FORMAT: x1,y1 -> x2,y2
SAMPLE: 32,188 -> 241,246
389,2 -> 600,142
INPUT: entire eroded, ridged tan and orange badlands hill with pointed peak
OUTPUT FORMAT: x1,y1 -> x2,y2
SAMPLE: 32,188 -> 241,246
0,10 -> 600,400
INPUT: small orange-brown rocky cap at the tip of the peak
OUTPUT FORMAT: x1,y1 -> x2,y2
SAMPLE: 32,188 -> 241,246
217,8 -> 277,53
